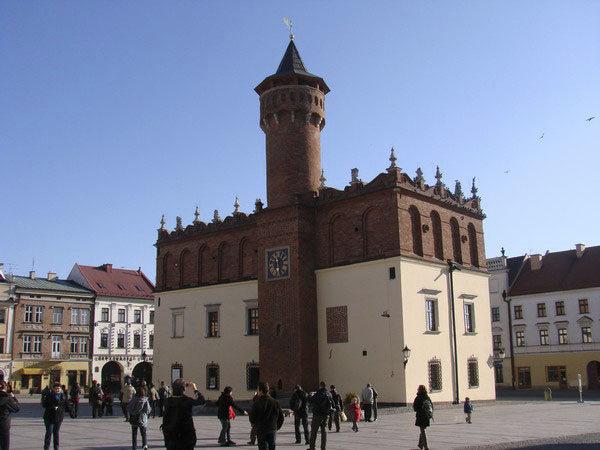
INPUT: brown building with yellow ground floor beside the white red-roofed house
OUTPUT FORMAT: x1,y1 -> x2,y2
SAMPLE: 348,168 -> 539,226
11,271 -> 94,393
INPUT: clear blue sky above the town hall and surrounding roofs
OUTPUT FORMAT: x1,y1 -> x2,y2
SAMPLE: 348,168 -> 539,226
0,0 -> 600,279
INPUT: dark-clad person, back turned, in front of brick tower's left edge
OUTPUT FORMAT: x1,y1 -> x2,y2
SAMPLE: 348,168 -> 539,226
250,383 -> 283,450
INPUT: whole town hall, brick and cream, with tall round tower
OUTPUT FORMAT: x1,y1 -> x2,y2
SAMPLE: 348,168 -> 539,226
153,40 -> 495,403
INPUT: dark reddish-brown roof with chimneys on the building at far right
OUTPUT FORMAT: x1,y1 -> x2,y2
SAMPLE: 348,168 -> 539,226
509,246 -> 600,296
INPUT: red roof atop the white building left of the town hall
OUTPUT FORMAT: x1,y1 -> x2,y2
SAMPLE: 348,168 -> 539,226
76,264 -> 154,299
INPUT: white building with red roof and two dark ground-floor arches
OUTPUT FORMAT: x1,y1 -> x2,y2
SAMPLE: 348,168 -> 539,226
68,264 -> 154,392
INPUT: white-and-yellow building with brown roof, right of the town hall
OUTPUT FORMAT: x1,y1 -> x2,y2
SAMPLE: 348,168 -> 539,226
490,244 -> 600,389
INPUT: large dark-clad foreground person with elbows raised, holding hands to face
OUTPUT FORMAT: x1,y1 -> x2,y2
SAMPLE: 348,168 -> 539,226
160,378 -> 206,450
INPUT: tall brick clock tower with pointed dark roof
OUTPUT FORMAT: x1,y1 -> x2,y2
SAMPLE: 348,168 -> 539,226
255,40 -> 329,392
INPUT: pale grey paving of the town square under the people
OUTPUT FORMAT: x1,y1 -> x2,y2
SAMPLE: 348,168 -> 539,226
11,397 -> 600,450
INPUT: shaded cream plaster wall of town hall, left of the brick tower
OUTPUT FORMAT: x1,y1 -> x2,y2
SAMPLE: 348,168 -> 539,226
153,281 -> 258,400
